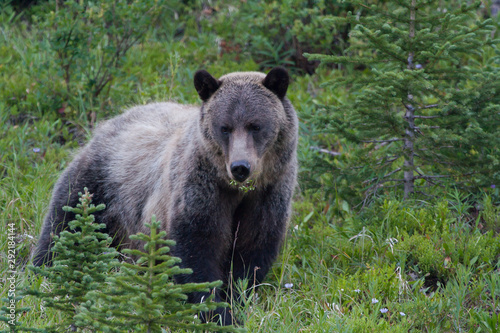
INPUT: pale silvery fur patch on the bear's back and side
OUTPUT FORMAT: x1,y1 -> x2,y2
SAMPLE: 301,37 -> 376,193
88,102 -> 200,240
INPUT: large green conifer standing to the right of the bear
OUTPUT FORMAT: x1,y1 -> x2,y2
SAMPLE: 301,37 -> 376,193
308,0 -> 500,199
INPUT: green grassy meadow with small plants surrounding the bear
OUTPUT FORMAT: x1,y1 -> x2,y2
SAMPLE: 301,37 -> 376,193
0,0 -> 500,332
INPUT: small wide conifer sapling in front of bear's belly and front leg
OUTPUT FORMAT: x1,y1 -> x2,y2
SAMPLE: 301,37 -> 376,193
77,217 -> 245,332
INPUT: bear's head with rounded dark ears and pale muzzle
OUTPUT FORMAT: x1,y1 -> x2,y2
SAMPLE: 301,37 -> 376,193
194,67 -> 295,187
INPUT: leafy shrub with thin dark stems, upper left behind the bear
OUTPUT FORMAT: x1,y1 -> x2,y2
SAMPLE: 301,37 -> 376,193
35,0 -> 164,119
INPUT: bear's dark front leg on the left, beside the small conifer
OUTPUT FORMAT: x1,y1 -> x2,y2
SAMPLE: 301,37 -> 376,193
169,185 -> 233,325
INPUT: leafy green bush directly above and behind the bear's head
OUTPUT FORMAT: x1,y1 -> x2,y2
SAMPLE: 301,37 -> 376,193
201,0 -> 350,74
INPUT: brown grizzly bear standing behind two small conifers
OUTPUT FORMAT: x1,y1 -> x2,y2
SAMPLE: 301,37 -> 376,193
33,67 -> 298,325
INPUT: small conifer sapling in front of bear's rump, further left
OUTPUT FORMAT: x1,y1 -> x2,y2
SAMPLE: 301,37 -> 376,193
26,188 -> 118,331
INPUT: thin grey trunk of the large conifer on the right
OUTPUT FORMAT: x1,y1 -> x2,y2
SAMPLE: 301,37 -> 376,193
403,0 -> 417,199
